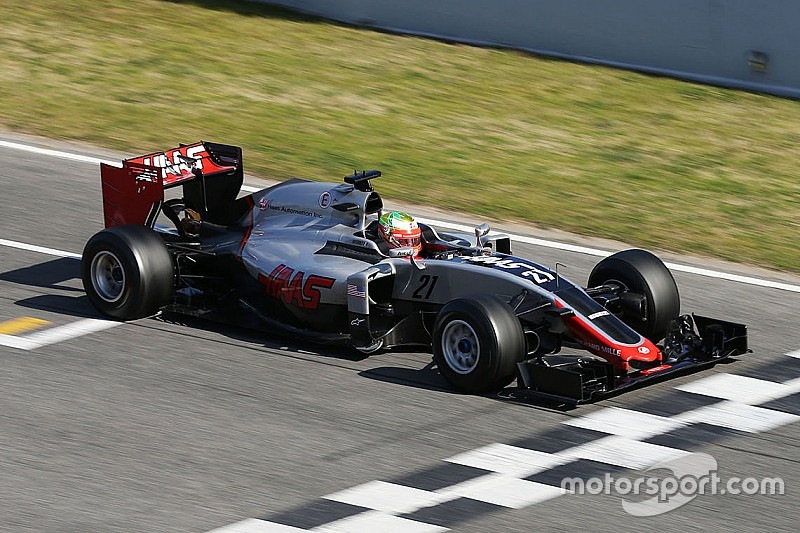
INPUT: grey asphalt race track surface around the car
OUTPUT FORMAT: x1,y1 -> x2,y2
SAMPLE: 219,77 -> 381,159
0,133 -> 800,533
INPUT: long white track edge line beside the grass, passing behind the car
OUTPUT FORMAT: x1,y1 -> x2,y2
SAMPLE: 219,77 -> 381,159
0,140 -> 800,293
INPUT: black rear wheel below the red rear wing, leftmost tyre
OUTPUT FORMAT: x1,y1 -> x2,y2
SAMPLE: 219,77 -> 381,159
81,225 -> 175,320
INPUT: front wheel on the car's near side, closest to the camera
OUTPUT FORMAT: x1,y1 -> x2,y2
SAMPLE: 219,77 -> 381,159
433,295 -> 526,394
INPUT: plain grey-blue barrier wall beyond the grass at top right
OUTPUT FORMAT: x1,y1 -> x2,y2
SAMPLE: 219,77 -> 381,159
259,0 -> 800,98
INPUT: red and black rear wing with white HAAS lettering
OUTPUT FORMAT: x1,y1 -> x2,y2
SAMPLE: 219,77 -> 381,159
100,141 -> 244,228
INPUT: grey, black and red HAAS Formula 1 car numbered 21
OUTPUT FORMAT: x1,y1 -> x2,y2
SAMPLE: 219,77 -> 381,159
81,142 -> 749,403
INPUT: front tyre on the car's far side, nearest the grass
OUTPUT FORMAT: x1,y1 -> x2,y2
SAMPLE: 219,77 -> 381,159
589,249 -> 681,342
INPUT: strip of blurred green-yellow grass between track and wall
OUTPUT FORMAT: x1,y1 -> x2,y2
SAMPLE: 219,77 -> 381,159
0,0 -> 800,272
